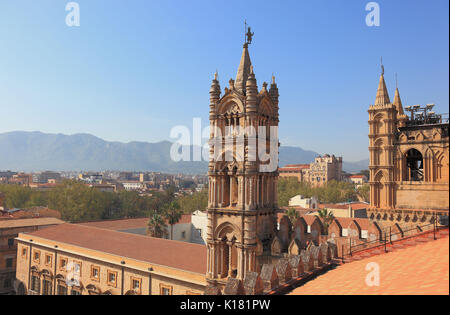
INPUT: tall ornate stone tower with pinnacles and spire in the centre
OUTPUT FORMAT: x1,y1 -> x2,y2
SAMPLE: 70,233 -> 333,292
206,41 -> 279,287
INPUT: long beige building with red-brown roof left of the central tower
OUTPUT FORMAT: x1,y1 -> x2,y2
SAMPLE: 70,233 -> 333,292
15,224 -> 206,295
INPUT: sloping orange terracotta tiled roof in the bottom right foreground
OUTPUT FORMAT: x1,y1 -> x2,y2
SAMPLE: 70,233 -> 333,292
291,237 -> 449,295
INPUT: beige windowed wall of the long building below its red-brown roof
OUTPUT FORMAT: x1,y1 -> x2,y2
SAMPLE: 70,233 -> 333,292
16,241 -> 205,295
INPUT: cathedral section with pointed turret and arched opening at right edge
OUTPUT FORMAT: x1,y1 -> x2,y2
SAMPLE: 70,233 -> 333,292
368,65 -> 449,223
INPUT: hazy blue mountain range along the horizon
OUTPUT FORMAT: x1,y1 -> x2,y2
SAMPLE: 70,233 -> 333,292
0,131 -> 369,174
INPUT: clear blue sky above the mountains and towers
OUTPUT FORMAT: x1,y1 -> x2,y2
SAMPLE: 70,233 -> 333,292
0,0 -> 449,161
